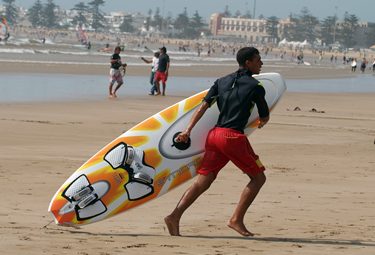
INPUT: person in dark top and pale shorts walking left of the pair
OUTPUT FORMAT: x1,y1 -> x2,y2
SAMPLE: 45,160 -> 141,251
109,46 -> 126,98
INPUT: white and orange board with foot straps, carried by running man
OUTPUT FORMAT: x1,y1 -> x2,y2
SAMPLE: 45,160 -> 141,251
48,73 -> 286,226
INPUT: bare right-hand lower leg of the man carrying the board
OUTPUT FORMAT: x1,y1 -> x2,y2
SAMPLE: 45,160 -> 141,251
228,172 -> 266,236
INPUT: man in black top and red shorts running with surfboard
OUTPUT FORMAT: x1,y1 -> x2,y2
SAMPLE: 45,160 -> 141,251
164,47 -> 269,236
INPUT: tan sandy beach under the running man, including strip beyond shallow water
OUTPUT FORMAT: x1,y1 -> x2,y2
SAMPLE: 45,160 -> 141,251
0,55 -> 375,255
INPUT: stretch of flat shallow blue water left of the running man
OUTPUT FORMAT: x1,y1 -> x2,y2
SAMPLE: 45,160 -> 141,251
0,73 -> 215,103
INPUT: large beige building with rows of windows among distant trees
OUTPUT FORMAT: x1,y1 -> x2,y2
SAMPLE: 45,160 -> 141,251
210,13 -> 271,43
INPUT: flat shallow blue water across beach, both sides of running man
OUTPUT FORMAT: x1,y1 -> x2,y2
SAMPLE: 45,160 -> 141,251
0,73 -> 375,103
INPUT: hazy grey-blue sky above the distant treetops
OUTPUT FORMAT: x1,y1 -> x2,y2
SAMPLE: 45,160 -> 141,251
11,0 -> 375,22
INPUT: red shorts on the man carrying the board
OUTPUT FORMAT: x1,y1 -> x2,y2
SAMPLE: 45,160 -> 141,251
197,127 -> 265,177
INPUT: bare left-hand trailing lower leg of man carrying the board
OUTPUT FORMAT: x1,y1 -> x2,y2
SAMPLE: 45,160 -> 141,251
164,173 -> 215,236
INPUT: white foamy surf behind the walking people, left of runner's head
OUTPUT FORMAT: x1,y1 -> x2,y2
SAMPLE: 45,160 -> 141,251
0,42 -> 235,66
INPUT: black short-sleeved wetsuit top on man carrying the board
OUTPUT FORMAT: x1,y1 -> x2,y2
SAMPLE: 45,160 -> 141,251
203,69 -> 269,133
